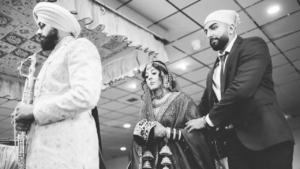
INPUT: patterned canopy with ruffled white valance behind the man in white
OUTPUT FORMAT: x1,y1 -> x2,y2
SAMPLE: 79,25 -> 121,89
0,0 -> 169,97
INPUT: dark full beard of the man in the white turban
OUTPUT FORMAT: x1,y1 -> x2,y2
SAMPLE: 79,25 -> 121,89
40,28 -> 58,51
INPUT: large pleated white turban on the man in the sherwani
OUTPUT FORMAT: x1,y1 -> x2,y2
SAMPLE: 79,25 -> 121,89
33,2 -> 81,38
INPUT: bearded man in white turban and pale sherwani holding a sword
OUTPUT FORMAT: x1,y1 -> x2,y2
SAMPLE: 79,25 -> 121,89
14,2 -> 102,169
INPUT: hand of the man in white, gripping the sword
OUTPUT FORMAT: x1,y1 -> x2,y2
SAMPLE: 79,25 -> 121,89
11,102 -> 34,122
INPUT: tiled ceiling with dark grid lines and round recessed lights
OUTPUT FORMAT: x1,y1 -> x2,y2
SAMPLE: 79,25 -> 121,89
0,0 -> 300,159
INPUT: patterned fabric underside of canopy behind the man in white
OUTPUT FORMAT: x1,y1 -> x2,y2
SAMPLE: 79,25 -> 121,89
0,0 -> 127,76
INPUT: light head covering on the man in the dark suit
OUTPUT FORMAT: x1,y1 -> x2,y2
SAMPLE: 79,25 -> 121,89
204,10 -> 241,28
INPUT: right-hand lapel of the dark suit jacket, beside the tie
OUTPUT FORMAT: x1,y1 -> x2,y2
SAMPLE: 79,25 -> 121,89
221,36 -> 243,95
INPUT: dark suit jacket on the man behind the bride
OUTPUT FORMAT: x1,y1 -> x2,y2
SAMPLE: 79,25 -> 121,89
199,36 -> 293,150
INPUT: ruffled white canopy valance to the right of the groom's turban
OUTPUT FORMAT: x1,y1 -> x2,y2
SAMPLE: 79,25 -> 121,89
56,0 -> 169,88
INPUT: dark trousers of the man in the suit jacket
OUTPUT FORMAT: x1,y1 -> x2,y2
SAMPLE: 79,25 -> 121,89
226,130 -> 294,169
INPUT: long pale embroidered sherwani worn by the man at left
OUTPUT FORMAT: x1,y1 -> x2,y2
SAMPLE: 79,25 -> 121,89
26,37 -> 102,169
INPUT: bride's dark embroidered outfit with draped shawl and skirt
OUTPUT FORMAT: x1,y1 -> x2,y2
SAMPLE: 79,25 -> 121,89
130,61 -> 215,169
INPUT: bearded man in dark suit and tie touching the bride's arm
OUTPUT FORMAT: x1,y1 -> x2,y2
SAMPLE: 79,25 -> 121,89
186,10 -> 294,169
